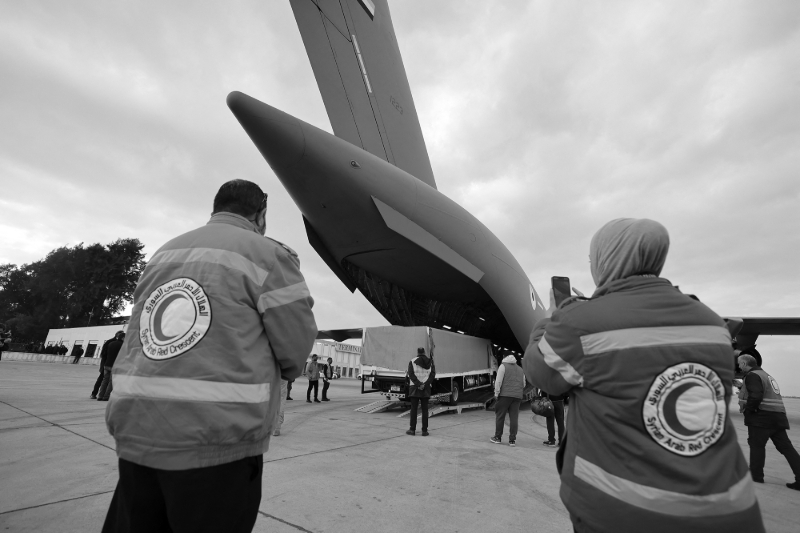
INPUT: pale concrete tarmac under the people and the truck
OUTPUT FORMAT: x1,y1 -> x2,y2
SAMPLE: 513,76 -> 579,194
0,360 -> 800,533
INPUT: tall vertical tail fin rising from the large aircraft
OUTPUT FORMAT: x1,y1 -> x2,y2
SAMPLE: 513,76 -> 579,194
291,0 -> 436,188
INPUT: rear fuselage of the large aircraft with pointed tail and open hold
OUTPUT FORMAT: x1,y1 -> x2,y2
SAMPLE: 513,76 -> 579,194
228,92 -> 544,350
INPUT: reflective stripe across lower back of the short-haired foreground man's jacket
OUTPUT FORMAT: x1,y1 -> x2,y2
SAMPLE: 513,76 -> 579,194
112,374 -> 270,403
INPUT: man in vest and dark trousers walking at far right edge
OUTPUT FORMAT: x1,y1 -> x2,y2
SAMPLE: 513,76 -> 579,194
739,354 -> 800,490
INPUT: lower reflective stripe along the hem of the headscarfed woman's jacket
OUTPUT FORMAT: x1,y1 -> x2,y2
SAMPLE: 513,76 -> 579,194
575,457 -> 756,517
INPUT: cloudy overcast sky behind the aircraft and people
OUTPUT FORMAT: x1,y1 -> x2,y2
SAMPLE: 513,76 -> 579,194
0,0 -> 800,395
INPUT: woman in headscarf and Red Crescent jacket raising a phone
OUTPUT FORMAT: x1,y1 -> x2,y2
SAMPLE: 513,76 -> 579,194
523,219 -> 764,533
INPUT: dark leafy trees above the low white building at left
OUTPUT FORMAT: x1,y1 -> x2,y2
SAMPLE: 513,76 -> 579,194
0,239 -> 145,341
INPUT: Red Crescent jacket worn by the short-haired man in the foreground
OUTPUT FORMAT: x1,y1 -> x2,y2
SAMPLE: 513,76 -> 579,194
106,213 -> 317,470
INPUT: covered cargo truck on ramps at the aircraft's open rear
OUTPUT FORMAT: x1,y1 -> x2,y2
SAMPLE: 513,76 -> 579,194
361,326 -> 497,405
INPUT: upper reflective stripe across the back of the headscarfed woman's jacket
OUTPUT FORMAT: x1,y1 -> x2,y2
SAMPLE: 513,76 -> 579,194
581,326 -> 731,355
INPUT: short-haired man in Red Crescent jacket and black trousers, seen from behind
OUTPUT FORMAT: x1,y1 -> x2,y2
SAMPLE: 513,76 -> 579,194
103,180 -> 317,532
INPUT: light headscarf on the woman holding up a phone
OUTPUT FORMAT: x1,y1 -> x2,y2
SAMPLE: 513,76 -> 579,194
589,218 -> 669,287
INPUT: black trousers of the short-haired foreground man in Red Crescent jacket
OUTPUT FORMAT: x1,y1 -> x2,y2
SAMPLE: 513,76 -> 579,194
103,455 -> 264,533
